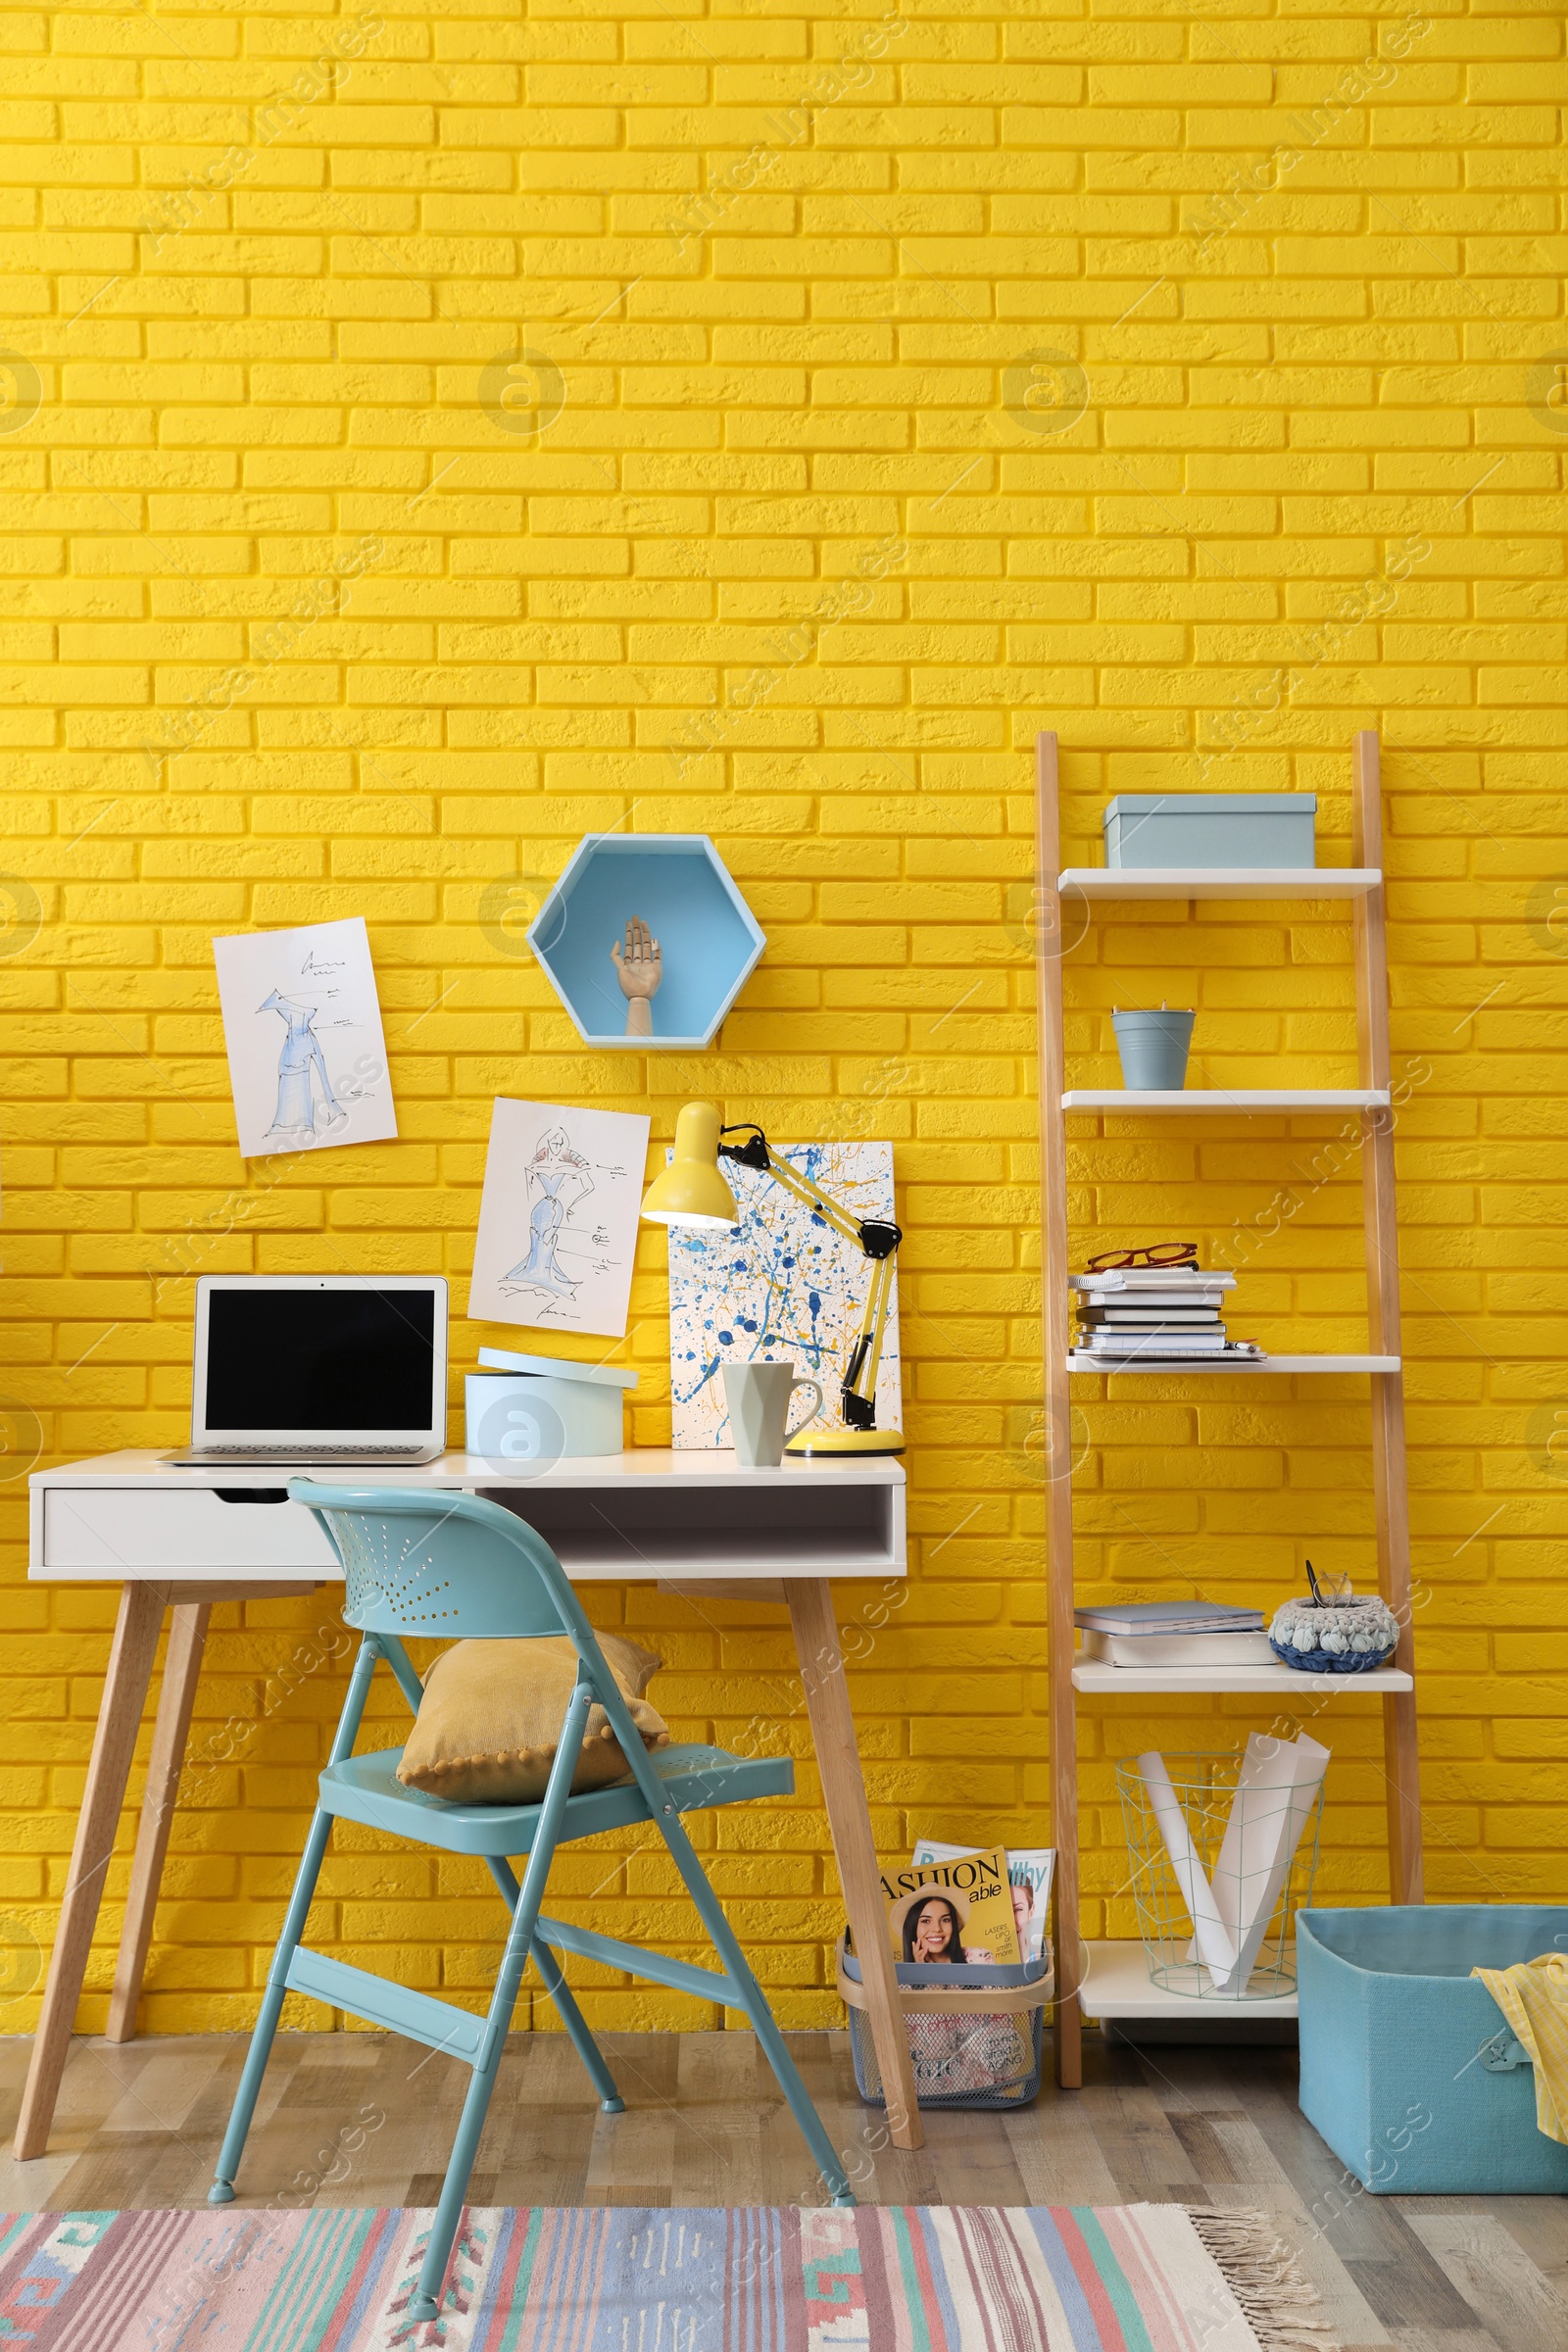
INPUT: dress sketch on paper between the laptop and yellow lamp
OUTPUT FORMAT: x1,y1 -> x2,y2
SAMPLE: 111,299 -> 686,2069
467,1096 -> 649,1339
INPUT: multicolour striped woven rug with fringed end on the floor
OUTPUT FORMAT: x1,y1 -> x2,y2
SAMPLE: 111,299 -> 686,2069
0,2204 -> 1331,2352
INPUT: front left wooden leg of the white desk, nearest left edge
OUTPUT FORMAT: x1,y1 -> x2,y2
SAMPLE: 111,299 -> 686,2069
17,1583 -> 170,2162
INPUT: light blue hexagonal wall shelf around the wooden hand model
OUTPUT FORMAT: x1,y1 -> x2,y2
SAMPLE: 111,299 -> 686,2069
529,833 -> 766,1054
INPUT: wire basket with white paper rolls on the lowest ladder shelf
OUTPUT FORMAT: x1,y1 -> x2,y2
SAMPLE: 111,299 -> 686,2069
1116,1752 -> 1324,2006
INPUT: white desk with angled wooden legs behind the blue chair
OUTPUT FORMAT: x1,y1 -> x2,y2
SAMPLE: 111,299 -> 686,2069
17,1446 -> 921,2157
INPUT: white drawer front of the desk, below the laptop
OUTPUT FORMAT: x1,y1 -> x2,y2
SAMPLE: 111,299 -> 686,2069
30,1487 -> 343,1581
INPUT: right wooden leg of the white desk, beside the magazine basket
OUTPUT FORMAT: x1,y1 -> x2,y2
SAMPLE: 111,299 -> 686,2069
785,1576 -> 926,2147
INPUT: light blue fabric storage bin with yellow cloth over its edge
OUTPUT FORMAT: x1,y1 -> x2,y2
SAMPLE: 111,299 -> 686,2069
1296,1903 -> 1568,2197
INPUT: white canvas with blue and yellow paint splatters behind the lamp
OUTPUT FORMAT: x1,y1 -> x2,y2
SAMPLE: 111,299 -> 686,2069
670,1143 -> 903,1446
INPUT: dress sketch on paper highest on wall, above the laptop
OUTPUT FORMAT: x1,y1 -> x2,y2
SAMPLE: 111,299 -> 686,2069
212,915 -> 397,1159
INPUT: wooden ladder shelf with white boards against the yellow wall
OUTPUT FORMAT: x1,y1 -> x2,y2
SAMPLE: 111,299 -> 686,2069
1034,734 -> 1422,2088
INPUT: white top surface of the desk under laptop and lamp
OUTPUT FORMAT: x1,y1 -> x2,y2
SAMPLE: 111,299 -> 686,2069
28,1446 -> 906,1494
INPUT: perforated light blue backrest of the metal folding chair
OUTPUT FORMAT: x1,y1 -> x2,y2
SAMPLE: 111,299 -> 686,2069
289,1477 -> 597,1656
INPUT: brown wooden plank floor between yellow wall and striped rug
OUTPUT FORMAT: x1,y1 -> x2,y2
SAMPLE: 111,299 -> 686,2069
0,2033 -> 1568,2352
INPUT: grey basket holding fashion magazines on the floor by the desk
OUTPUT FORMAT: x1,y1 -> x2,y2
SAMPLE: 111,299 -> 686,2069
839,1940 -> 1055,2107
